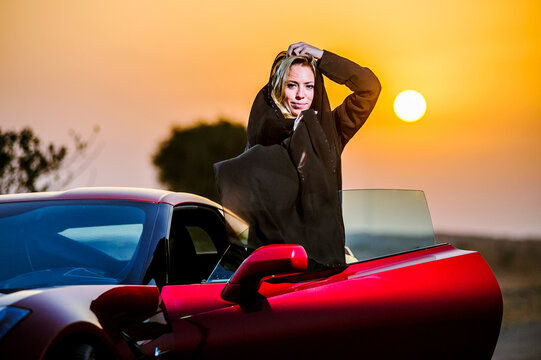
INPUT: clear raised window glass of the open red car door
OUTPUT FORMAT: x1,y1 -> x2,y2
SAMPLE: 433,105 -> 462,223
342,190 -> 436,263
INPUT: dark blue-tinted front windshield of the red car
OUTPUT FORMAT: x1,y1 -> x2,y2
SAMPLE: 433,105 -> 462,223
0,200 -> 156,289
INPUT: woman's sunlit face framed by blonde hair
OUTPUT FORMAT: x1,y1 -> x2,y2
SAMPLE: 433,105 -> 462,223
284,64 -> 314,116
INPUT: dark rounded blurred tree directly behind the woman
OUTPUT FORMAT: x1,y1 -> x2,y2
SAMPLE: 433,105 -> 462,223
153,118 -> 246,201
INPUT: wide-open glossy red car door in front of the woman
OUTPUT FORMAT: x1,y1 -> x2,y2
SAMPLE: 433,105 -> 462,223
153,193 -> 502,359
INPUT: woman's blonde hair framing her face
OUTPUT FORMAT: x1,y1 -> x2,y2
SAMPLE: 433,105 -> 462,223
271,54 -> 316,119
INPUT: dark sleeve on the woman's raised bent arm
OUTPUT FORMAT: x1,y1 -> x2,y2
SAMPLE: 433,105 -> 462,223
318,50 -> 381,148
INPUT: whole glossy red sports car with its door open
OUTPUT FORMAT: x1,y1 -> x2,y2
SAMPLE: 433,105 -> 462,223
0,188 -> 502,359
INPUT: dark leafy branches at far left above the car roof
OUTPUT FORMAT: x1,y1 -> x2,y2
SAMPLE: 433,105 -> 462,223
0,126 -> 99,194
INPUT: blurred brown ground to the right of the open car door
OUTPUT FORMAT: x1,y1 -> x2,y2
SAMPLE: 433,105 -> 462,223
437,234 -> 541,360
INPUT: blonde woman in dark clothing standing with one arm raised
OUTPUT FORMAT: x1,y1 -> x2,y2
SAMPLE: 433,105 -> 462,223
216,42 -> 381,266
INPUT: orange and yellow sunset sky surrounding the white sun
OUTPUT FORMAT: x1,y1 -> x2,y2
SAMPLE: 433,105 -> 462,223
0,0 -> 541,238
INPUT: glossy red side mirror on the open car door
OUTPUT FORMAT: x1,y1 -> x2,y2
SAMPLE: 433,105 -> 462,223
222,244 -> 308,303
